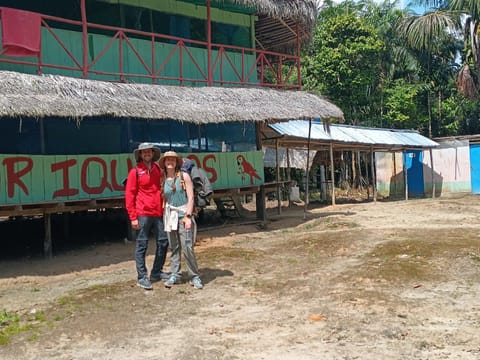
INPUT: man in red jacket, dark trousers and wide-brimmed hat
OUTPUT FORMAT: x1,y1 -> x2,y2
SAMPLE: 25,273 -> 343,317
125,143 -> 168,290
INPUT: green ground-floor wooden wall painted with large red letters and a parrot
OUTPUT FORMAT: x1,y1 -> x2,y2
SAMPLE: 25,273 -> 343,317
0,151 -> 264,205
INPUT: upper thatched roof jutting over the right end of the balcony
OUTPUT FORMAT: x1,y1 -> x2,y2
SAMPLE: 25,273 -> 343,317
227,0 -> 318,51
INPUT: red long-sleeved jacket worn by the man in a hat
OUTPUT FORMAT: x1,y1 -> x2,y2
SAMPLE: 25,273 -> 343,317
125,162 -> 163,221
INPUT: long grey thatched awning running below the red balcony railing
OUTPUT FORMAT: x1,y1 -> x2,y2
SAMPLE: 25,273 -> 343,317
0,71 -> 343,124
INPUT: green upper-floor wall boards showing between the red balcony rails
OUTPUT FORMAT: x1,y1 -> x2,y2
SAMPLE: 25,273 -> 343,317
0,28 -> 257,86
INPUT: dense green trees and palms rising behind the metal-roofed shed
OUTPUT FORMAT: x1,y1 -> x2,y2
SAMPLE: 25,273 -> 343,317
302,0 -> 480,137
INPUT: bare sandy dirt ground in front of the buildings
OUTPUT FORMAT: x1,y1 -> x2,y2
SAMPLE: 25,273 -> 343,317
0,195 -> 480,360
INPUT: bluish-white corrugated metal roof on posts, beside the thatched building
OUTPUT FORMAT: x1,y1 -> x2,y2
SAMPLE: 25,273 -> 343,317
268,120 -> 439,148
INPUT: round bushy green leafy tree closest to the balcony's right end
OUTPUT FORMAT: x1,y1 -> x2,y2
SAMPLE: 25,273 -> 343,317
302,2 -> 385,124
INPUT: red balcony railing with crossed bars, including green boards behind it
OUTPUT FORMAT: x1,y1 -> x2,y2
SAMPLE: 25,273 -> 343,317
0,7 -> 301,89
